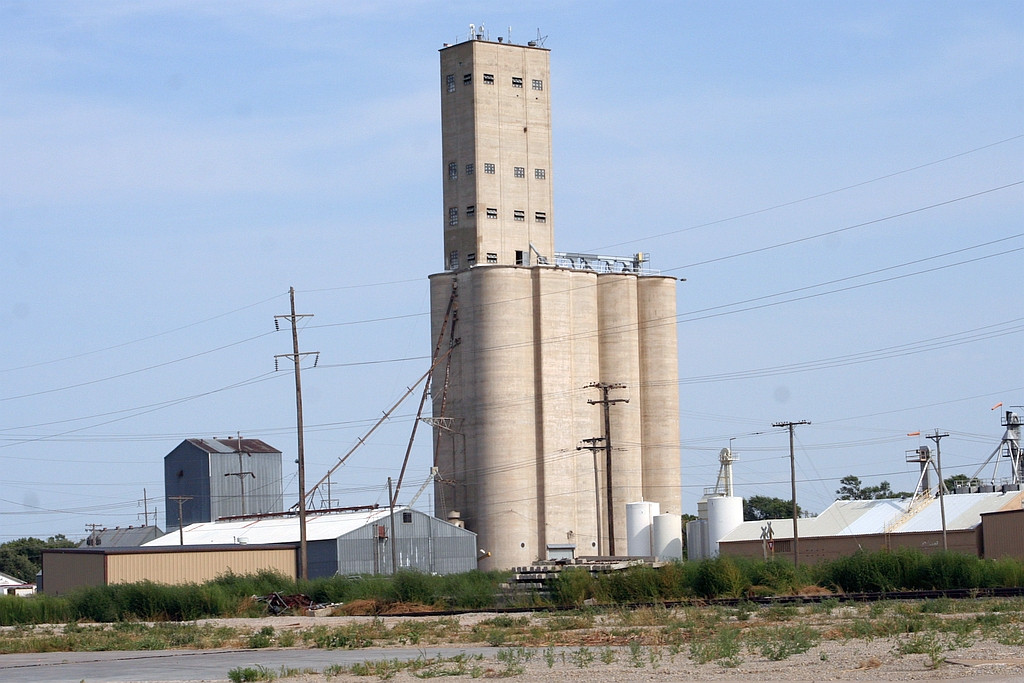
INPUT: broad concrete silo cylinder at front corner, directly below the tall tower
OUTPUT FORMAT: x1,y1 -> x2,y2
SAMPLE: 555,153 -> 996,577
455,265 -> 545,569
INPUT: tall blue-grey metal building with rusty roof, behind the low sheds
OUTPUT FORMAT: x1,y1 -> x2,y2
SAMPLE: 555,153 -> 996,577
164,438 -> 285,529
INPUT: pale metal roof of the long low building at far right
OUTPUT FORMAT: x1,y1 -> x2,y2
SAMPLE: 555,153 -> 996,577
721,490 -> 1024,542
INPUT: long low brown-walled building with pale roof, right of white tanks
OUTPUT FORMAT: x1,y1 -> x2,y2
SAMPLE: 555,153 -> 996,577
719,492 -> 1024,562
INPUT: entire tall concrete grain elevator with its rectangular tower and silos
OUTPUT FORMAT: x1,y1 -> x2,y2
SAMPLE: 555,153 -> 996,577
430,29 -> 681,569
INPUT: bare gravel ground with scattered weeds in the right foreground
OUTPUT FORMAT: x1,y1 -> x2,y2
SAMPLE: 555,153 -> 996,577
197,613 -> 1024,683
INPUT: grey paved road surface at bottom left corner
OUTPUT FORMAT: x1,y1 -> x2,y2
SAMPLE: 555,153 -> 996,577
0,647 -> 500,683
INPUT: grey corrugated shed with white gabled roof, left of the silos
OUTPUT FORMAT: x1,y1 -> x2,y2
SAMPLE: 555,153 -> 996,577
144,508 -> 477,579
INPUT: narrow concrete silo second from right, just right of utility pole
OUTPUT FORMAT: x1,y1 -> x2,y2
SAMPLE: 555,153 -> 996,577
591,273 -> 643,554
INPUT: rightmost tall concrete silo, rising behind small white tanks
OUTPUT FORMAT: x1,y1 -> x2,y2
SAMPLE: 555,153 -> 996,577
637,276 -> 682,513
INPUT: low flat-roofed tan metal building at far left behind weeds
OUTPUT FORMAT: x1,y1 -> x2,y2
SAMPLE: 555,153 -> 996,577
41,544 -> 298,595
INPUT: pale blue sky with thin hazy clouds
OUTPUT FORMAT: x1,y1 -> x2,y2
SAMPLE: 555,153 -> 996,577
0,0 -> 1024,542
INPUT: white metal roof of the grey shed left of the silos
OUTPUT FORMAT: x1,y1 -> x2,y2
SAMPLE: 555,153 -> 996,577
143,507 -> 397,547
